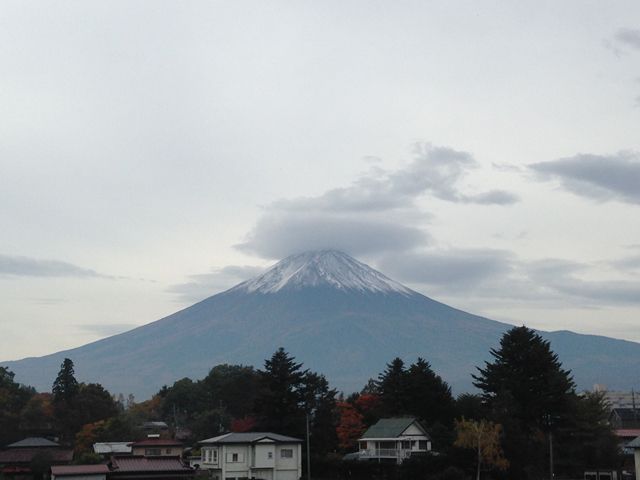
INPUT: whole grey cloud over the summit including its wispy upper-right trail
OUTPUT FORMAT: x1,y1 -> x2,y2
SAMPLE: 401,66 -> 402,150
236,143 -> 517,258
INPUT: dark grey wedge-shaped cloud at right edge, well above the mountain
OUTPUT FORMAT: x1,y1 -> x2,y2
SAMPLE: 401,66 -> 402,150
529,152 -> 640,204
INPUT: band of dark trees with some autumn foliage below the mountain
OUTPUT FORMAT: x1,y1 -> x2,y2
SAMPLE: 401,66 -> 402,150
0,327 -> 619,480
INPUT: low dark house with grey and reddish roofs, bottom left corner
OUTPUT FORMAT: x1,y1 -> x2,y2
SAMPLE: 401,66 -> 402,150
0,437 -> 73,479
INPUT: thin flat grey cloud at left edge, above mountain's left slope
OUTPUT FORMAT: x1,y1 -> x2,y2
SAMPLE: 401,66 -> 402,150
0,254 -> 112,278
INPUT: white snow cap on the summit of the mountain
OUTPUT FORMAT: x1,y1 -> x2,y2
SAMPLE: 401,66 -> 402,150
232,250 -> 414,296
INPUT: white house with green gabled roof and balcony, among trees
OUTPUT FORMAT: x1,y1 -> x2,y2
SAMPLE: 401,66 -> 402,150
357,417 -> 431,463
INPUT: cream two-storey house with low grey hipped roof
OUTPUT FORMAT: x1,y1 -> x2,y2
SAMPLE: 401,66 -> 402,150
198,432 -> 302,480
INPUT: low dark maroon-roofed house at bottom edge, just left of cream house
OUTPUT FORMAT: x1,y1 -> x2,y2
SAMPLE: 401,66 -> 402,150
108,455 -> 195,480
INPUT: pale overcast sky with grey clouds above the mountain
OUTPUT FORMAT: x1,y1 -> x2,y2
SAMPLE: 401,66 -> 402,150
0,0 -> 640,360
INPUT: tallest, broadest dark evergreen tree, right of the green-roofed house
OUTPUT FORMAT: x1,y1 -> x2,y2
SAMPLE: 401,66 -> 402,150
473,327 -> 575,480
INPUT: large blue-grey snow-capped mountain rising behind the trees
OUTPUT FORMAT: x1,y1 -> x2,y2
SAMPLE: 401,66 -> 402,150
5,250 -> 640,399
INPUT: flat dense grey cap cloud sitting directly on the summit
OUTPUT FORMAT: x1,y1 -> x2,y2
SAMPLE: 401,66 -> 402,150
236,212 -> 428,259
